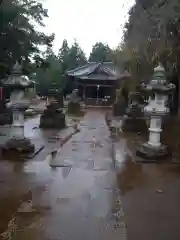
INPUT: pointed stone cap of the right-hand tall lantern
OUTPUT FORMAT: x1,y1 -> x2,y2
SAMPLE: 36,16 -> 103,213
141,64 -> 175,93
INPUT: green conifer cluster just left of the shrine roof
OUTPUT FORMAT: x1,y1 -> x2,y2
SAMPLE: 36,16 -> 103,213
36,40 -> 87,95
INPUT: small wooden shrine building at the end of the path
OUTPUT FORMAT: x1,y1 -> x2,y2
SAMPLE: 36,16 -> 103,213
66,62 -> 131,104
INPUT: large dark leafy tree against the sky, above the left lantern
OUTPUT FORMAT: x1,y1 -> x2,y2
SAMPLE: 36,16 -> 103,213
0,0 -> 54,76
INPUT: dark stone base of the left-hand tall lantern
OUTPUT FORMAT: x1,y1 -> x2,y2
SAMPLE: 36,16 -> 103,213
3,138 -> 35,153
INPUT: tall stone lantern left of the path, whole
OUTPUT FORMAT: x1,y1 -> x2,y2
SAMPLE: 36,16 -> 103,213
3,63 -> 34,152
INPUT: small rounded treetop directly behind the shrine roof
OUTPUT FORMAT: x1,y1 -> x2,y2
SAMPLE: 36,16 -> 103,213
89,42 -> 112,62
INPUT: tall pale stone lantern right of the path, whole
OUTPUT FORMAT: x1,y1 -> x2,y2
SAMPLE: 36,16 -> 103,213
136,65 -> 175,160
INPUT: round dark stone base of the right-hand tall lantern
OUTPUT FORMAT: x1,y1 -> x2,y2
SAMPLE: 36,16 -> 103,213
136,143 -> 171,162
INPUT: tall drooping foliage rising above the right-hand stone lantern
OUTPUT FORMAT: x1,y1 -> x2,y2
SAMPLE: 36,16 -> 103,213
124,0 -> 180,75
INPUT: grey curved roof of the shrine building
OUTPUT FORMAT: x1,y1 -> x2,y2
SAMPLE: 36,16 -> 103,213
66,62 -> 131,80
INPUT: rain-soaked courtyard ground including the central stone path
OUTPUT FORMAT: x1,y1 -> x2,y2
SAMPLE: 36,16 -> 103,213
0,110 -> 180,240
